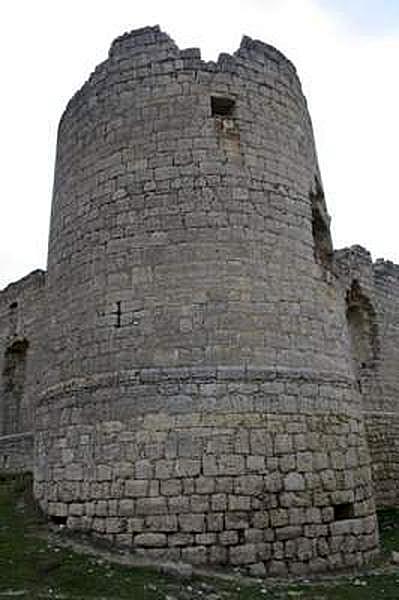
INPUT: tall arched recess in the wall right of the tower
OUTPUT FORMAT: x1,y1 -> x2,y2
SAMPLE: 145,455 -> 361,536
346,279 -> 378,389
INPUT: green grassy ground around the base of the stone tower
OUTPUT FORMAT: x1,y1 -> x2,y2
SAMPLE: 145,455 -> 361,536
0,476 -> 399,600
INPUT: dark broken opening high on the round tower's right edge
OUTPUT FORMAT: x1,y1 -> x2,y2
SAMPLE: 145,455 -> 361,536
310,178 -> 333,270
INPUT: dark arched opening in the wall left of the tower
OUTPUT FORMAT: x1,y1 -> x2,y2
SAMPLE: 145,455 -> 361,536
1,340 -> 29,435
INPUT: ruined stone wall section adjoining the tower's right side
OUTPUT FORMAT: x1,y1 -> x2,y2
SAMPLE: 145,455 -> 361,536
334,246 -> 399,506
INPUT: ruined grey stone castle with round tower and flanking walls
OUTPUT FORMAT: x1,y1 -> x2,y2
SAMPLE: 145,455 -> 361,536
0,27 -> 399,575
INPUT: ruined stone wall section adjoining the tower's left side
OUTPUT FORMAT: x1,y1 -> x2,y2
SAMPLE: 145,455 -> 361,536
0,270 -> 45,471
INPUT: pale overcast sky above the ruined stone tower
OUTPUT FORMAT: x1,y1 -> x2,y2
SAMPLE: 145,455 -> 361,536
0,0 -> 399,289
